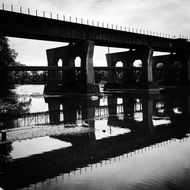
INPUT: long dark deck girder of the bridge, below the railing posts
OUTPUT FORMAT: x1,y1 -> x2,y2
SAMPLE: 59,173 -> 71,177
0,10 -> 190,51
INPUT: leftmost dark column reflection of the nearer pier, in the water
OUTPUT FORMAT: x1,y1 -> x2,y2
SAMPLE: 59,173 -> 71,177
48,101 -> 60,124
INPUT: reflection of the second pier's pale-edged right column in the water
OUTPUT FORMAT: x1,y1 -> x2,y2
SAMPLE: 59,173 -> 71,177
142,99 -> 154,133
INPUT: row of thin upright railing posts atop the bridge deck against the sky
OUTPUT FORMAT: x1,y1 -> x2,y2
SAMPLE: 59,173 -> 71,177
0,3 -> 190,41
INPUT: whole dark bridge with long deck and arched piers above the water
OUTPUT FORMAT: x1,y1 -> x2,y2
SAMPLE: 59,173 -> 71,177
0,7 -> 190,93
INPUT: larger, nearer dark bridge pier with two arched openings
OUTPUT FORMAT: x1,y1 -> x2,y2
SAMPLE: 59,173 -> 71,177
45,41 -> 99,93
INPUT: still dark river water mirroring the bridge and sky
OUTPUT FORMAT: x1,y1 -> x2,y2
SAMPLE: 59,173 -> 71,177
0,85 -> 190,190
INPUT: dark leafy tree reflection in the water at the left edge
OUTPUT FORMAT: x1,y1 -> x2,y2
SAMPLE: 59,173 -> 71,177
0,91 -> 31,128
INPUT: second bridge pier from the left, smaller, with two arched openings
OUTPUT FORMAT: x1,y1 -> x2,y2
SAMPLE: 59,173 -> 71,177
106,47 -> 158,90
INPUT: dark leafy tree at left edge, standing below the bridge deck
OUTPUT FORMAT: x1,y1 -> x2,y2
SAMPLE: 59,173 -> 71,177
0,36 -> 18,94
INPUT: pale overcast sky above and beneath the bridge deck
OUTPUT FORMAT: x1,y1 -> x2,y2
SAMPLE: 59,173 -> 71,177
0,0 -> 190,65
